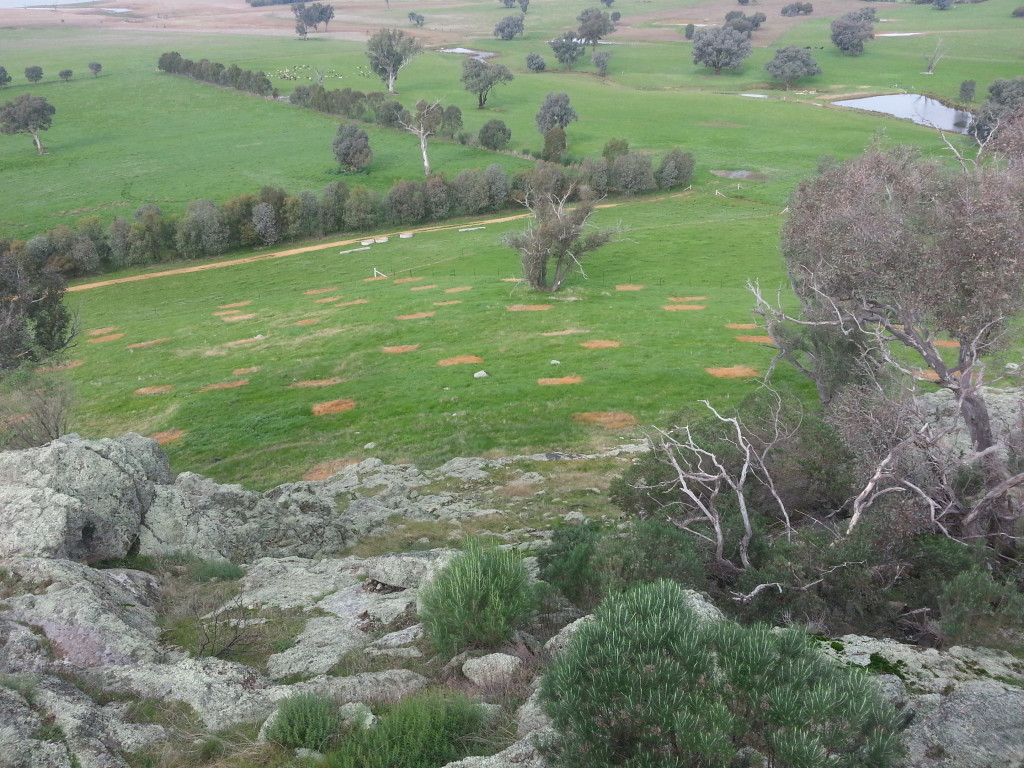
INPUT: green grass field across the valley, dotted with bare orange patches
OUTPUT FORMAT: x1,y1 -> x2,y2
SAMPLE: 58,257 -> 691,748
0,0 -> 1020,487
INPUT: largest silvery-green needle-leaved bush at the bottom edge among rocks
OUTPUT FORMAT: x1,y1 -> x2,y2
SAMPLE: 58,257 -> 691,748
541,581 -> 899,768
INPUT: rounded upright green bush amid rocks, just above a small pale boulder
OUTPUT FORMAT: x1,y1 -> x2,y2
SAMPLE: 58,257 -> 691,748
420,542 -> 538,653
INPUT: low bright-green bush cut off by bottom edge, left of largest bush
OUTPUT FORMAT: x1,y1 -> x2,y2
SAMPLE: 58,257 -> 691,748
327,692 -> 484,768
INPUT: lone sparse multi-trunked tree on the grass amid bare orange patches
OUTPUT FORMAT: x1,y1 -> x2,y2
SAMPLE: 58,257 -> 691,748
502,186 -> 612,293
